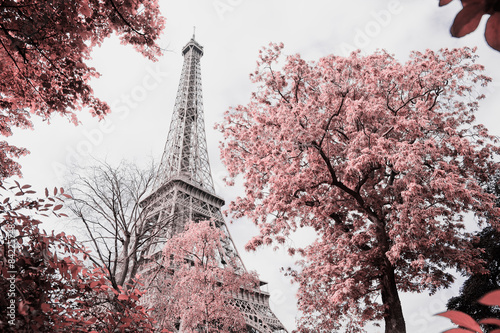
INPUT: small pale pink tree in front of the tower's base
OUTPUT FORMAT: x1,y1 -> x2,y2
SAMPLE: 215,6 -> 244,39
145,221 -> 258,333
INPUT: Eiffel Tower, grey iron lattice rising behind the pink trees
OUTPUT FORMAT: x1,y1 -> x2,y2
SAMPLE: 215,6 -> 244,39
142,34 -> 287,333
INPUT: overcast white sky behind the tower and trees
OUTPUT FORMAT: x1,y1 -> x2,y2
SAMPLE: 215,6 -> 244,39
8,0 -> 500,332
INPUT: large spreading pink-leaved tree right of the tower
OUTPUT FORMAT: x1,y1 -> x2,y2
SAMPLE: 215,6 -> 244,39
216,44 -> 500,332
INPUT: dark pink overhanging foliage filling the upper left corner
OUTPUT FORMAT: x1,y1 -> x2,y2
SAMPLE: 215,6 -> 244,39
0,0 -> 164,179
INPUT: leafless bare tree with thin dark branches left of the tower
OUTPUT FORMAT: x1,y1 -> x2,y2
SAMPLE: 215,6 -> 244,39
64,161 -> 156,287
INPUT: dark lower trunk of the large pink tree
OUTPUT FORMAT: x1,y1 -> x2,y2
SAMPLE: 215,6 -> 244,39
380,256 -> 406,333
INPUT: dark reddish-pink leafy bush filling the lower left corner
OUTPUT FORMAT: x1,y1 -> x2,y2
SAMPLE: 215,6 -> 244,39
0,183 -> 153,333
